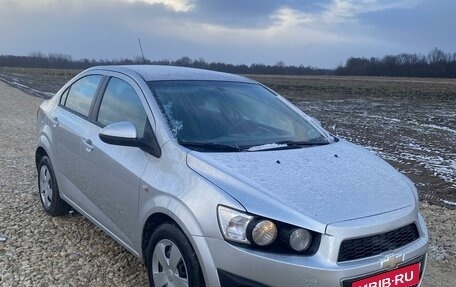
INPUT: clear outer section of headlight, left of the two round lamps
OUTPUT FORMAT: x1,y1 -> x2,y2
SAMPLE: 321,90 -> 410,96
218,206 -> 253,244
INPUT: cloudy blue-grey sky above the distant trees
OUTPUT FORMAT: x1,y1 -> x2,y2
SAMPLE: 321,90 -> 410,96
0,0 -> 456,68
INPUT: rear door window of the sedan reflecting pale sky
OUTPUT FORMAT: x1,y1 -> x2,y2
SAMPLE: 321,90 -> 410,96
61,75 -> 102,117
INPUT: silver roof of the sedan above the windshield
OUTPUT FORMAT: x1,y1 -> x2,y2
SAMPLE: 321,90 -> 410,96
88,65 -> 257,83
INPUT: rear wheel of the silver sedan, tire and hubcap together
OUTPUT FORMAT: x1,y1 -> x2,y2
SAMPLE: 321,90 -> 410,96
38,156 -> 70,216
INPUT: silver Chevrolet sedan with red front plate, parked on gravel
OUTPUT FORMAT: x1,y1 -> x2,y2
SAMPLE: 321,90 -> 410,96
36,66 -> 428,287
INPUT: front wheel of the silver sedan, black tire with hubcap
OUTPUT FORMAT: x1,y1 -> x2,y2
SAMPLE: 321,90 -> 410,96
147,223 -> 205,287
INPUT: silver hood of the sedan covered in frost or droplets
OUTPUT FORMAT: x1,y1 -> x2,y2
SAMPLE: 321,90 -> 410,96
187,140 -> 416,233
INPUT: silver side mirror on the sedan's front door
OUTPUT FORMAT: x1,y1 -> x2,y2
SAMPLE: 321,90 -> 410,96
99,122 -> 141,147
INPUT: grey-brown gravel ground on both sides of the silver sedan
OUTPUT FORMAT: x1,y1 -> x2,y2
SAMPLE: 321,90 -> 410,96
0,82 -> 456,287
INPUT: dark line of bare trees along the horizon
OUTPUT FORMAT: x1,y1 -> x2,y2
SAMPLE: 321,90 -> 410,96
0,48 -> 456,78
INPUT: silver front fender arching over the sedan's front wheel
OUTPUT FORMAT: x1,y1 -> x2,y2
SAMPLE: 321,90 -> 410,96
135,142 -> 245,287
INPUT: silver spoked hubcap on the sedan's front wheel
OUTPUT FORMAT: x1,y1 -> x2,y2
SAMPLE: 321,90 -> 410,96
152,239 -> 188,287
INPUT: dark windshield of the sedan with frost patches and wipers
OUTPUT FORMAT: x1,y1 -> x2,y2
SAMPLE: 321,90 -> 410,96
149,81 -> 328,151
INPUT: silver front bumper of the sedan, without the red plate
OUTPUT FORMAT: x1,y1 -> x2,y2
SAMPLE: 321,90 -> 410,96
196,213 -> 429,287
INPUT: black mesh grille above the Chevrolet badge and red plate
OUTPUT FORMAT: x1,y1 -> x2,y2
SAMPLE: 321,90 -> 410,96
338,223 -> 419,262
